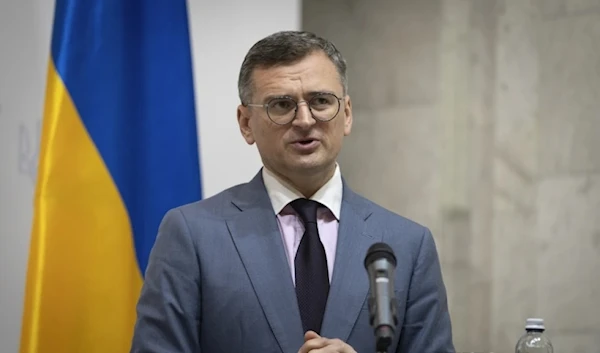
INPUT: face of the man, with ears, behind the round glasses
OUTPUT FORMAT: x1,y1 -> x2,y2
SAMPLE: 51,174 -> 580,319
238,51 -> 352,177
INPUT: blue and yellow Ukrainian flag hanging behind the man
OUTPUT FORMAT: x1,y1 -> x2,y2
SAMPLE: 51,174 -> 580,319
20,0 -> 201,353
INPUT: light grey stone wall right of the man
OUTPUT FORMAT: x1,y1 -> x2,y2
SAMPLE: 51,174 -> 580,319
303,0 -> 600,353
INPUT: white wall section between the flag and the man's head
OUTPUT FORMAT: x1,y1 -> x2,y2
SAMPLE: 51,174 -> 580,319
188,0 -> 301,196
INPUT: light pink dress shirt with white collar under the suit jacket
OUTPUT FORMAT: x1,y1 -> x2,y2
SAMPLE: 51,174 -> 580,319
262,165 -> 343,285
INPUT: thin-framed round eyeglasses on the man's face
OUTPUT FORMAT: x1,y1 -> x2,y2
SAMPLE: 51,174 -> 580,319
244,93 -> 344,125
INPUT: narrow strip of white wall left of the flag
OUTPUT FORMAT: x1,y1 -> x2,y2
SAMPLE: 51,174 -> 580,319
0,0 -> 54,353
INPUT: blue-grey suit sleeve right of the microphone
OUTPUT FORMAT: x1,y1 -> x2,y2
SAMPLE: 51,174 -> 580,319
397,229 -> 455,353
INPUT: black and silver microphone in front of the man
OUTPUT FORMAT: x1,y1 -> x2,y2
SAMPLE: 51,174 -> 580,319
364,243 -> 398,353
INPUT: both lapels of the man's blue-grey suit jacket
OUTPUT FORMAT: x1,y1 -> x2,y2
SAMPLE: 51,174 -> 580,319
227,172 -> 372,353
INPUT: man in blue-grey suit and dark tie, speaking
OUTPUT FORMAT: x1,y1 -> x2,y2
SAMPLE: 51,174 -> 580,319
132,32 -> 454,353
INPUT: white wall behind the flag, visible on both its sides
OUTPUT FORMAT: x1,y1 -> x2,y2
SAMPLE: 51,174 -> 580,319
0,0 -> 301,353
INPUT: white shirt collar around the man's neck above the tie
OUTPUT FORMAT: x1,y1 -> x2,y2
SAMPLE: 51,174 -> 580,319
262,163 -> 343,220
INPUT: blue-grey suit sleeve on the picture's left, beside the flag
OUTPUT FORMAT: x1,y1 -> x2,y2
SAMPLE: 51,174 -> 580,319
130,209 -> 201,353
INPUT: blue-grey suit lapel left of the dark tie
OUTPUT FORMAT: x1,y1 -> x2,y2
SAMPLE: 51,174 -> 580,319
227,173 -> 304,353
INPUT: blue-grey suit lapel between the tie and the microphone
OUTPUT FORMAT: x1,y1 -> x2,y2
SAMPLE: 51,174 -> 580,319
322,182 -> 378,341
